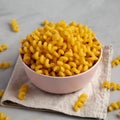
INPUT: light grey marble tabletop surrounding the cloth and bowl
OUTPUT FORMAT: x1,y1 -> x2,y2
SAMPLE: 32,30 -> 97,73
0,0 -> 120,120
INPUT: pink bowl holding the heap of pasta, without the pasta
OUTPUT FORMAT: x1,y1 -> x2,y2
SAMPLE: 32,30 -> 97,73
20,51 -> 102,94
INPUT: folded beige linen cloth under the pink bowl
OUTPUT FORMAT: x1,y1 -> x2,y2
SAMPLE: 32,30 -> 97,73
1,46 -> 112,119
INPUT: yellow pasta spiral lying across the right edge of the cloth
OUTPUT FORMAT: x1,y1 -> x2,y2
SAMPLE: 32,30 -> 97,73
102,80 -> 120,91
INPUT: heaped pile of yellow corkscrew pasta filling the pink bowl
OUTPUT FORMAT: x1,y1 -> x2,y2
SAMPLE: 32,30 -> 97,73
19,20 -> 102,77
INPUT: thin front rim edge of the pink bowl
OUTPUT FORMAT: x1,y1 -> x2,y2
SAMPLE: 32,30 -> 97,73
19,48 -> 103,79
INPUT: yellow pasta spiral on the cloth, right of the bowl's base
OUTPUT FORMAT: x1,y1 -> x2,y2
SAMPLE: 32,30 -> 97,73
73,93 -> 88,112
